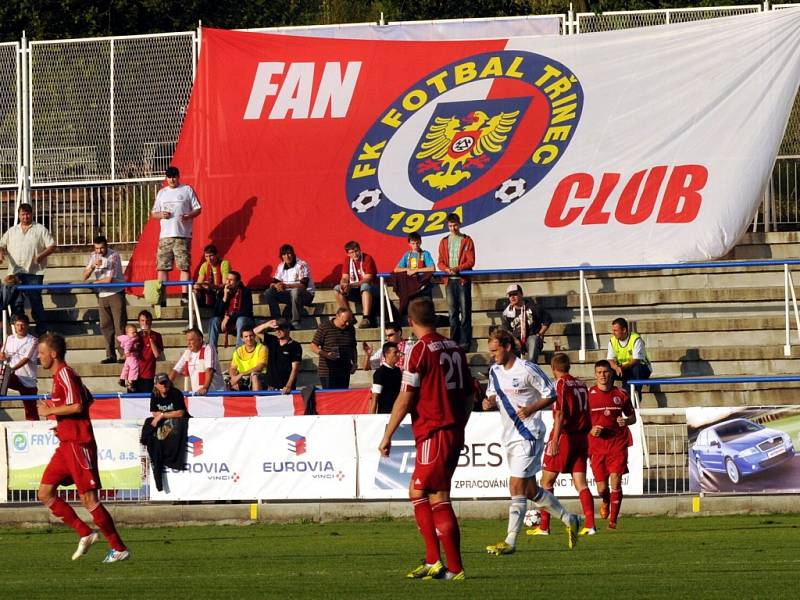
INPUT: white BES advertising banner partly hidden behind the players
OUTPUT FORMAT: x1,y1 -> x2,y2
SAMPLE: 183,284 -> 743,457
355,412 -> 643,499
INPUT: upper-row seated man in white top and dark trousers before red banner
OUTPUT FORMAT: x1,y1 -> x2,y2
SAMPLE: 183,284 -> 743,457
264,244 -> 314,329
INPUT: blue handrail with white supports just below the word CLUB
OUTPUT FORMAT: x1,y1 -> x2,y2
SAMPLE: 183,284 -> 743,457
378,259 -> 800,362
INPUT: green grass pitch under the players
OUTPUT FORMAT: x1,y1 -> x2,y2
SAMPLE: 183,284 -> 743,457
0,514 -> 800,600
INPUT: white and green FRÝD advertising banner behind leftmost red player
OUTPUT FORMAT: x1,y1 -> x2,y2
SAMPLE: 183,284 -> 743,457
5,421 -> 142,490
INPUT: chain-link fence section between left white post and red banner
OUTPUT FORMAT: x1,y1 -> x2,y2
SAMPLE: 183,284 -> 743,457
30,32 -> 195,185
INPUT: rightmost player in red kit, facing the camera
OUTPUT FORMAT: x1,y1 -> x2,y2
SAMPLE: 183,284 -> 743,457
589,360 -> 636,529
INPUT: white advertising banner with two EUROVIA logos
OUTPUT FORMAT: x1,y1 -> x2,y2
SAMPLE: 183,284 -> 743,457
149,416 -> 358,500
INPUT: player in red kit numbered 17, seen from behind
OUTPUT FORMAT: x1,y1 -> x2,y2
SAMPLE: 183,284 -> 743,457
529,353 -> 597,535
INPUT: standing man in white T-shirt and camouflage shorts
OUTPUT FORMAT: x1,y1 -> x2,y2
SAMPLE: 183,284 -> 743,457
150,166 -> 202,302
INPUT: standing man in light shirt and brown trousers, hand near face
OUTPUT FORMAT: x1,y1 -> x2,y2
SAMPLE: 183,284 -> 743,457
83,235 -> 128,365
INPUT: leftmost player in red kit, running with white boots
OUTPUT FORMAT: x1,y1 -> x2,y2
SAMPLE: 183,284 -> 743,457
39,333 -> 130,562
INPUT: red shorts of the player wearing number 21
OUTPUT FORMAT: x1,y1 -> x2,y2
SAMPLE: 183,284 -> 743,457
411,428 -> 464,492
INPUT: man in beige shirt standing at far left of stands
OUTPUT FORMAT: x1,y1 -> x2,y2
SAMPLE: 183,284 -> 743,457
0,202 -> 56,336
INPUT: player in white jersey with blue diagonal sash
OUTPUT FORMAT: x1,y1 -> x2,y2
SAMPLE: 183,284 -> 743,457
483,329 -> 580,556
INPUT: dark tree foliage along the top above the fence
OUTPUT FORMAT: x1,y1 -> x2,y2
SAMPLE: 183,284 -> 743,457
0,0 -> 776,41
